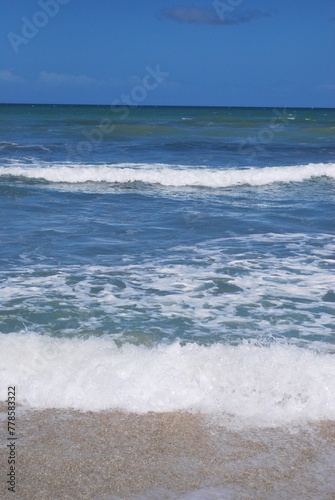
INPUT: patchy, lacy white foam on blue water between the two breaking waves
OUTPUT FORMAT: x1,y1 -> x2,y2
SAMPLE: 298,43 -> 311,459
0,233 -> 335,342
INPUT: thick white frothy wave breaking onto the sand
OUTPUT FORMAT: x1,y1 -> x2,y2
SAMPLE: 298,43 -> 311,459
0,333 -> 335,426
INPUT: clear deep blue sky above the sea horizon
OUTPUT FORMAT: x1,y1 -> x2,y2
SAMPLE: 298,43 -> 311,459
0,0 -> 335,107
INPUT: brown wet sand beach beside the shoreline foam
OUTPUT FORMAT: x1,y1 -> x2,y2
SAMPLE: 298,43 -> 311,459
0,406 -> 335,500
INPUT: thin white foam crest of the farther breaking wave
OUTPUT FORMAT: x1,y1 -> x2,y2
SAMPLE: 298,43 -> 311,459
0,163 -> 335,188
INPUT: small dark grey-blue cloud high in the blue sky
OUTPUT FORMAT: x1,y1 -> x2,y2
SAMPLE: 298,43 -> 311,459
161,7 -> 272,26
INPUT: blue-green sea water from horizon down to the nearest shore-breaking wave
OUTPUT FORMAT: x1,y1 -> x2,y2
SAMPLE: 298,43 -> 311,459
0,105 -> 335,343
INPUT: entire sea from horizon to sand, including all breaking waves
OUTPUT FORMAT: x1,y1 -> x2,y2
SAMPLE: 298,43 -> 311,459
0,105 -> 335,426
